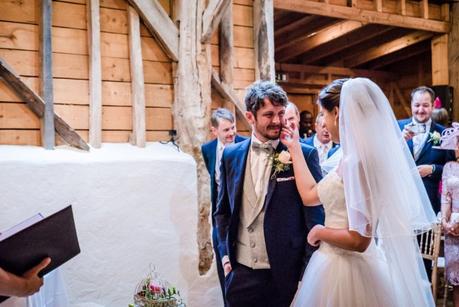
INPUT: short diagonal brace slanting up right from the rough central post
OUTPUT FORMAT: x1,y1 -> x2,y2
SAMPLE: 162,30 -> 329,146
201,0 -> 232,44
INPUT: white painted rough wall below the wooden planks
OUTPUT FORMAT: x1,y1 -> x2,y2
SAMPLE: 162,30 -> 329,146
0,143 -> 223,307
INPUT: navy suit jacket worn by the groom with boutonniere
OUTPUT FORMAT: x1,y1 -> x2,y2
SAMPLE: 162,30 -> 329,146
214,139 -> 324,297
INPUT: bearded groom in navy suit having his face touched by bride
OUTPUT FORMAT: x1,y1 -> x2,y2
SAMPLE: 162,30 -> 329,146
214,81 -> 324,307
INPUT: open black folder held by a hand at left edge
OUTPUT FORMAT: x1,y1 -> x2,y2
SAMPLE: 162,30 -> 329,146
0,206 -> 80,302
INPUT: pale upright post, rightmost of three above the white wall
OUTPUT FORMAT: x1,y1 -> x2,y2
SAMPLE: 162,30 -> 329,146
128,6 -> 146,147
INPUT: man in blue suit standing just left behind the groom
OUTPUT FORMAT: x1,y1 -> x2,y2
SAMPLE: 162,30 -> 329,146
201,108 -> 246,300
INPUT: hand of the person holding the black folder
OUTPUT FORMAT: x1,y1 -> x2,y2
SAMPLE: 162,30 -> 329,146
0,258 -> 51,296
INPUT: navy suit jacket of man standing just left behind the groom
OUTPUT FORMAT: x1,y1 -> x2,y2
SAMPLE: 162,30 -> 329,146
201,135 -> 246,226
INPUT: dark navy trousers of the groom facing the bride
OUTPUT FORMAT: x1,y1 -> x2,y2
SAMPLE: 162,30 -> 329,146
225,263 -> 296,307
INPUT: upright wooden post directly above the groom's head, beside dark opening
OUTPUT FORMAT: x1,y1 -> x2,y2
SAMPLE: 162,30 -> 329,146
253,0 -> 276,81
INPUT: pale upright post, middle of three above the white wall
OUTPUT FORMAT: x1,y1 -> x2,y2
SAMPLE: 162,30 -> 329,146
88,0 -> 102,148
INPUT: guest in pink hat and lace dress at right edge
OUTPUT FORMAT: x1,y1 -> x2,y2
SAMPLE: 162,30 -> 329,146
441,123 -> 459,307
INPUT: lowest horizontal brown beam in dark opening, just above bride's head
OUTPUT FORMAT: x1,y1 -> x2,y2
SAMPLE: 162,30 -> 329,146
276,63 -> 397,80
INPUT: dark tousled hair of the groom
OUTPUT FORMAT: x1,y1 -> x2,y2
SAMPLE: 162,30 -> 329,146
245,81 -> 288,115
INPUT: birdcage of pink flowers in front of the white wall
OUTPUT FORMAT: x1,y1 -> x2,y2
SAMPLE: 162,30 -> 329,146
129,270 -> 185,307
